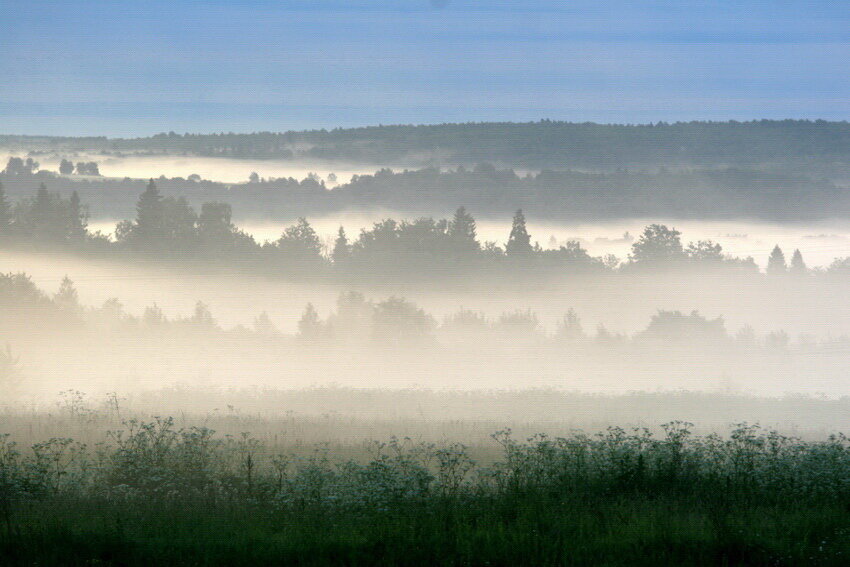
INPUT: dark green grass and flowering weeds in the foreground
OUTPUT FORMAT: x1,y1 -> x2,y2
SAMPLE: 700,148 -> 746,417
0,420 -> 850,565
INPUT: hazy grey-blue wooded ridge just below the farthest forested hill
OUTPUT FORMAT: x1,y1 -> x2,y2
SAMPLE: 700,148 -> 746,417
0,158 -> 850,221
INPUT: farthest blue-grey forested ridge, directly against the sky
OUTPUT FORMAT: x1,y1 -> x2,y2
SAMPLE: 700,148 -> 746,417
11,120 -> 850,170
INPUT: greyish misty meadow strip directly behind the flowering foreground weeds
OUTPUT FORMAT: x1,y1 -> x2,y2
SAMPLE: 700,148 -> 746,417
6,387 -> 850,449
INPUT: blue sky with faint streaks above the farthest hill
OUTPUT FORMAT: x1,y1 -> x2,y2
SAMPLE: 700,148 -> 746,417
0,0 -> 850,136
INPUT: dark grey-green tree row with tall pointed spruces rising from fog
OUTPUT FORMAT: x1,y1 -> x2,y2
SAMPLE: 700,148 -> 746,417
0,180 -> 836,275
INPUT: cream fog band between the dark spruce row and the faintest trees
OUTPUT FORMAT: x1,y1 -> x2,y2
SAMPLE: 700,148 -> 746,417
0,250 -> 850,340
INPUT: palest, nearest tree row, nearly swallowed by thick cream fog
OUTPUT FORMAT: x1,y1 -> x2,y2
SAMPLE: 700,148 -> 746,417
0,273 -> 820,356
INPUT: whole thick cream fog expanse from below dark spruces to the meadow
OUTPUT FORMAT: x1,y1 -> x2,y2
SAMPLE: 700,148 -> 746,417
2,242 -> 850,406
